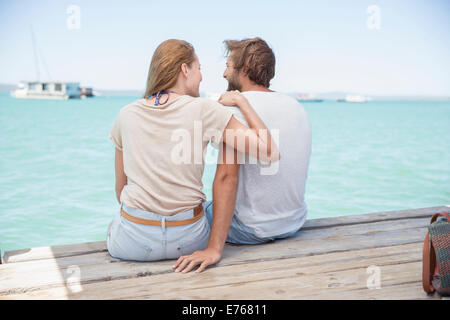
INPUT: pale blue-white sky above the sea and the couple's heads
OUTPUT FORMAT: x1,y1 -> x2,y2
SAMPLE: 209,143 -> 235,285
0,0 -> 450,96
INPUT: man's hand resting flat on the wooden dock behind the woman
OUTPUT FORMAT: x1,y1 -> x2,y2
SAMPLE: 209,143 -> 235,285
172,248 -> 222,273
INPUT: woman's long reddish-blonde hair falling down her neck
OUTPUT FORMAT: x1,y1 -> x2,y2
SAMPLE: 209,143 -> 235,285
144,39 -> 195,98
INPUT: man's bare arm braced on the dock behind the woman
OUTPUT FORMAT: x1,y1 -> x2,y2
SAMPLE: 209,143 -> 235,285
173,144 -> 239,273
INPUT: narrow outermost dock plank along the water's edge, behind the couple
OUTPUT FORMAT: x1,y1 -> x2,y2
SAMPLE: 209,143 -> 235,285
3,206 -> 450,263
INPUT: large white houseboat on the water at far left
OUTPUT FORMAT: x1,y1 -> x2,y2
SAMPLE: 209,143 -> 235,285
11,81 -> 82,100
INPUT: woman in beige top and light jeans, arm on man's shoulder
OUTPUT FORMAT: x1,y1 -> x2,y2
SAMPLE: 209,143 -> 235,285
107,39 -> 279,261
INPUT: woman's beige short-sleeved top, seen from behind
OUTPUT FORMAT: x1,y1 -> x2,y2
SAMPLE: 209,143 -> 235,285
109,95 -> 233,216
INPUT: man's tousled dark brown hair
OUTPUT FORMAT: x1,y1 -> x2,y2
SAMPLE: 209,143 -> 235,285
224,38 -> 275,88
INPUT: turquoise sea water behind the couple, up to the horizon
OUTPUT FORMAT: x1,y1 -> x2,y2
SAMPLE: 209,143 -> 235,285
0,94 -> 450,252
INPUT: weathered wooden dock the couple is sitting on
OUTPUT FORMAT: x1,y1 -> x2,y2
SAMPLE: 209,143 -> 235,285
0,205 -> 450,300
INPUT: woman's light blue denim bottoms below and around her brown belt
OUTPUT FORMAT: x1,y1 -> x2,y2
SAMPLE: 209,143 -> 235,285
106,203 -> 210,261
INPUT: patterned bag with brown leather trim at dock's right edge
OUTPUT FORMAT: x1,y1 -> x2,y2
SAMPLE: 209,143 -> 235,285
422,212 -> 450,295
